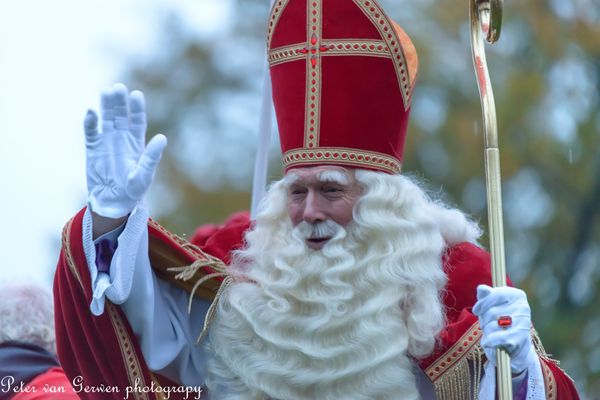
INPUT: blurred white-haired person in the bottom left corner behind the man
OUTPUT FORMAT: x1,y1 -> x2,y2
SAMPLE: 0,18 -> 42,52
0,284 -> 78,400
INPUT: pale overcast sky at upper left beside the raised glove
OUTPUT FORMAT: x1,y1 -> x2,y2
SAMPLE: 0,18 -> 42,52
0,0 -> 231,284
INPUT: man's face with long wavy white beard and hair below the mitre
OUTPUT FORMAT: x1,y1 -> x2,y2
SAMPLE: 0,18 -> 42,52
208,167 -> 464,399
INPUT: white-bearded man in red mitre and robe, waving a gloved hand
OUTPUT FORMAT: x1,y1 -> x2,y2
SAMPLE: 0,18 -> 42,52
55,0 -> 577,400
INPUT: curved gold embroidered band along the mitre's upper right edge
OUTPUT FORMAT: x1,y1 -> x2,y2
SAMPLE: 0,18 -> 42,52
352,0 -> 411,110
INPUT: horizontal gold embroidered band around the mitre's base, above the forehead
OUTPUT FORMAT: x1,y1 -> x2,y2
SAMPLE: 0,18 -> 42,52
283,147 -> 402,174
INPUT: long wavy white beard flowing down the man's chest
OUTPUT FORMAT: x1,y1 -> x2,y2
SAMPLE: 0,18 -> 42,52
206,172 -> 478,400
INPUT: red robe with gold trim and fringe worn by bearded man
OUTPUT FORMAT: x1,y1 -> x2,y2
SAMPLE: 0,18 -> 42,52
54,210 -> 579,400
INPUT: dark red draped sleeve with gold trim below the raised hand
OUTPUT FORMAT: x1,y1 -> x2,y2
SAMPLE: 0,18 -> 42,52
54,210 -> 191,400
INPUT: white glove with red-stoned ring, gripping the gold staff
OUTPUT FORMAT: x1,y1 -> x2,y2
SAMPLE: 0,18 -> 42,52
473,285 -> 537,374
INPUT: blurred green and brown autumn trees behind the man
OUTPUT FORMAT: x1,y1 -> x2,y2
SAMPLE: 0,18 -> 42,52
123,0 -> 600,399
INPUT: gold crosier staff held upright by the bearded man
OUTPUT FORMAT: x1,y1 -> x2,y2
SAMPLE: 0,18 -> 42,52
469,0 -> 512,400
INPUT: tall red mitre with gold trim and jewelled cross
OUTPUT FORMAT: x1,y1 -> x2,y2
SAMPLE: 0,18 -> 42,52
267,0 -> 417,174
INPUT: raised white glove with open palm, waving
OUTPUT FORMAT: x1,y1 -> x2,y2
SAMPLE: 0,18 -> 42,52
84,84 -> 167,218
